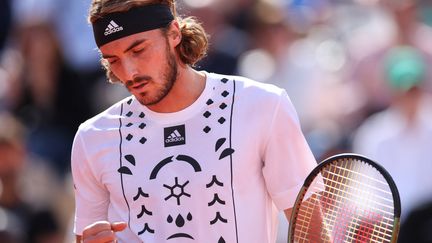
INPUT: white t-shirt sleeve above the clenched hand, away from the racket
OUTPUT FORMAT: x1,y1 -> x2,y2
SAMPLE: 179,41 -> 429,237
71,131 -> 109,235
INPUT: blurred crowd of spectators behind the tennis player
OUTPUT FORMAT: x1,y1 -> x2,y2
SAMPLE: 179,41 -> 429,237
0,0 -> 432,243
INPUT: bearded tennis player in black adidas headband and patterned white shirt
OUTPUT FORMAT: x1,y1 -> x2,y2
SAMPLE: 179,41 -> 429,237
72,0 -> 316,243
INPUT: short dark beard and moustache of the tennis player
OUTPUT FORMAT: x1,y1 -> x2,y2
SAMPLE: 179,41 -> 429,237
126,45 -> 178,106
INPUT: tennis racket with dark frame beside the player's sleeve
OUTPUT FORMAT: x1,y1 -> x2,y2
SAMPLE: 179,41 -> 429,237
288,153 -> 401,243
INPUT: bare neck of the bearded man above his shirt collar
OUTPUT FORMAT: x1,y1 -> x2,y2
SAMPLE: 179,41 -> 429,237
147,66 -> 205,113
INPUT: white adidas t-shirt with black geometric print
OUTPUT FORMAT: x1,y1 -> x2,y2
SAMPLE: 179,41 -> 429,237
72,73 -> 316,243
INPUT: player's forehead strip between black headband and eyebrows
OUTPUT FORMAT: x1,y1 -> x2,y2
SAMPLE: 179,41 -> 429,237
99,29 -> 162,54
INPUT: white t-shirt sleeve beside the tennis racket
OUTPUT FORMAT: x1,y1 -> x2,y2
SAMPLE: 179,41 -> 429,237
263,91 -> 317,210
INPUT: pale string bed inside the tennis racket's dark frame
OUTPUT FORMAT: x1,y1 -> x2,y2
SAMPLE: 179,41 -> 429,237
294,160 -> 394,242
